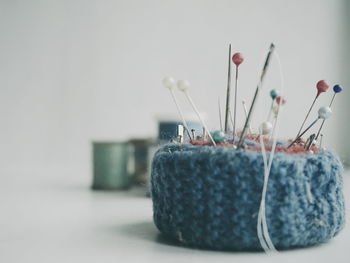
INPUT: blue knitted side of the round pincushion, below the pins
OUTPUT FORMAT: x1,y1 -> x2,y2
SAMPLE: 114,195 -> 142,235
151,144 -> 345,250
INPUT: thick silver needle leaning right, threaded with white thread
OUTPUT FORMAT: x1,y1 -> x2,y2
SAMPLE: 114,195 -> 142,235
237,43 -> 275,148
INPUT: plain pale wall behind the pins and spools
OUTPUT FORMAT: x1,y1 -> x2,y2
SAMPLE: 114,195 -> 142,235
0,0 -> 349,177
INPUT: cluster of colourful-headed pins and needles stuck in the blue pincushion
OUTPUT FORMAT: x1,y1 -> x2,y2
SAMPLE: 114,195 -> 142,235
163,43 -> 342,152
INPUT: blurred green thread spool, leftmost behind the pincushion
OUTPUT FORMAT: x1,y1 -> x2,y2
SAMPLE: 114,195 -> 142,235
92,142 -> 130,190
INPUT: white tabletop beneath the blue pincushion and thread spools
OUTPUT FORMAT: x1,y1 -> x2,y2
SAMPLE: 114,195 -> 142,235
0,172 -> 350,263
